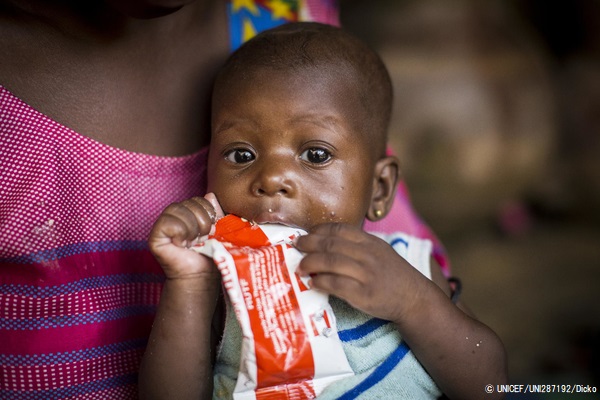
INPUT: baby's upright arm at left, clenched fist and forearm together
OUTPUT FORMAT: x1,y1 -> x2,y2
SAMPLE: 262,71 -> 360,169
139,195 -> 222,399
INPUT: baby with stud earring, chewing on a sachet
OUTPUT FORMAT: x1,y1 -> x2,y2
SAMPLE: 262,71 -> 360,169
140,23 -> 506,399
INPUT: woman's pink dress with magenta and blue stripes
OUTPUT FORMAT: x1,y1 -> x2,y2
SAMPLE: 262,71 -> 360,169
0,0 -> 445,400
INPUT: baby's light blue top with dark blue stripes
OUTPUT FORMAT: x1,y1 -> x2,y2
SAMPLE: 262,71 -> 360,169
213,234 -> 441,400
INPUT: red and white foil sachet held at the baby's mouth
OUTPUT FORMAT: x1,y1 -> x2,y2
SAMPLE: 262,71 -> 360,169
193,215 -> 354,400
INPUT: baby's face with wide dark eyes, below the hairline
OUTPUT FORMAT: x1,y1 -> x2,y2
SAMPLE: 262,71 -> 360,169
208,69 -> 375,230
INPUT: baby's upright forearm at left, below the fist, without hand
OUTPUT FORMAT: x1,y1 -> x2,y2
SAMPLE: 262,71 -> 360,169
139,278 -> 219,399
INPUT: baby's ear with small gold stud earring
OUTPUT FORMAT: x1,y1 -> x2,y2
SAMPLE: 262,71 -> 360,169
367,156 -> 400,221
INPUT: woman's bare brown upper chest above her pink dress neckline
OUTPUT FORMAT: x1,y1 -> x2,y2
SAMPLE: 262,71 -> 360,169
0,1 -> 230,156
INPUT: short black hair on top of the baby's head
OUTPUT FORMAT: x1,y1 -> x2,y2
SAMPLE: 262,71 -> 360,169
215,22 -> 393,153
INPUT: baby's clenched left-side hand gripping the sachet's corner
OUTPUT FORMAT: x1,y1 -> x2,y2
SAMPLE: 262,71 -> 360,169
148,193 -> 223,279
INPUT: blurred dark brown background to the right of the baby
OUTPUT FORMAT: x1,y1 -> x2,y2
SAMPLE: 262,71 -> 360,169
341,0 -> 600,399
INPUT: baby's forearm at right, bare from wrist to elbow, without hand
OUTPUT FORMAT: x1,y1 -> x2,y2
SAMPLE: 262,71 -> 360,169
396,280 -> 507,399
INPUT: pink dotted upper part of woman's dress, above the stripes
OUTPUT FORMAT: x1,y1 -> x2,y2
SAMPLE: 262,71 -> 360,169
0,89 -> 206,257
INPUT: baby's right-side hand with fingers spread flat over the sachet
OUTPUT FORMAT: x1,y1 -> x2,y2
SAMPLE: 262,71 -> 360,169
296,224 -> 426,321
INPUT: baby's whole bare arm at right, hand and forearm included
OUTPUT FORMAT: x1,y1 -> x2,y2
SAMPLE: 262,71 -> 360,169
296,224 -> 506,399
